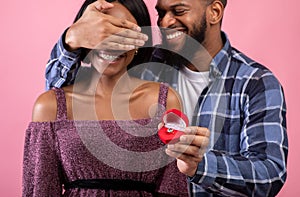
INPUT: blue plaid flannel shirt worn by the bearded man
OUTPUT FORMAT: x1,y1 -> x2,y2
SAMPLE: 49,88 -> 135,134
46,33 -> 288,196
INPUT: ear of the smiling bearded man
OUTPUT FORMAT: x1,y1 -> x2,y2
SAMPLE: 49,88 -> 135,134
207,0 -> 224,25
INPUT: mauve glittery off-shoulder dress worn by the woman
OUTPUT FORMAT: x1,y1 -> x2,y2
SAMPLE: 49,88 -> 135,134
22,83 -> 188,197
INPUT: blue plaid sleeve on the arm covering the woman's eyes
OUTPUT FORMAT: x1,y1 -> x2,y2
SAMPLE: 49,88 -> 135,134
45,31 -> 81,90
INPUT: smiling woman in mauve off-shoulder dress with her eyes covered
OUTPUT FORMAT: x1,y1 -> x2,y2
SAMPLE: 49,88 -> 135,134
23,0 -> 187,196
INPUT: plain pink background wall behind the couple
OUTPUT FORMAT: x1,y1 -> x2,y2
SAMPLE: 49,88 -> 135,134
0,0 -> 300,197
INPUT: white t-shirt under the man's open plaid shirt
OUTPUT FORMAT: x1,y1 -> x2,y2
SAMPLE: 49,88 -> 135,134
178,66 -> 209,124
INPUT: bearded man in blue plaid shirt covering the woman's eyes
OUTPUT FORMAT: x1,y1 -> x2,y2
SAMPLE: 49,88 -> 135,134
46,0 -> 288,196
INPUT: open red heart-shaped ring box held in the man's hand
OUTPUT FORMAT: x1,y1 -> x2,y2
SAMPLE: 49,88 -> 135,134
158,109 -> 189,144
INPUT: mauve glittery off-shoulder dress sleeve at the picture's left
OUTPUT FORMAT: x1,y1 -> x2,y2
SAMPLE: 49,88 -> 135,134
22,122 -> 63,197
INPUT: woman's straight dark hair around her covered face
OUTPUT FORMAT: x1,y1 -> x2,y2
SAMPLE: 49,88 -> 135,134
74,0 -> 152,69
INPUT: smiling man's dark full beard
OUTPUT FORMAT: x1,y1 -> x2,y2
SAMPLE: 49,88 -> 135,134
162,13 -> 207,68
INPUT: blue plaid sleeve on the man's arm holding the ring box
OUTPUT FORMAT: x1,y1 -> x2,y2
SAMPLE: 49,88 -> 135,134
188,58 -> 288,196
